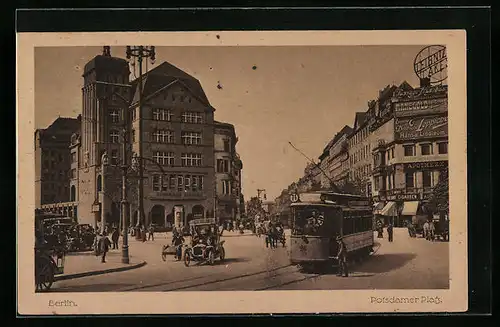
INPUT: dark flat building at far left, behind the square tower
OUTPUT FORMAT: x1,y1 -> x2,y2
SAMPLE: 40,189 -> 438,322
35,116 -> 81,208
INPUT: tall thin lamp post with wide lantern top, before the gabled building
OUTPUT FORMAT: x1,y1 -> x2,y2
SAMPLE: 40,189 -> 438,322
126,45 -> 156,234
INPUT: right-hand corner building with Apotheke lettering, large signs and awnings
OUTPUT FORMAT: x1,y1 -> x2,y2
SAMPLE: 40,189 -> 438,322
372,84 -> 448,226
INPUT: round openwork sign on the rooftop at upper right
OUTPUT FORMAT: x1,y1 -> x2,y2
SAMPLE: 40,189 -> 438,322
413,45 -> 448,84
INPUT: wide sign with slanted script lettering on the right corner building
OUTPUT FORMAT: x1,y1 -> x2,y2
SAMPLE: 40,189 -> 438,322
394,116 -> 448,140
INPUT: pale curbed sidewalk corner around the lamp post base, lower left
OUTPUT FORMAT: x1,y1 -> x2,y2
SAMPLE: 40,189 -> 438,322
54,250 -> 146,281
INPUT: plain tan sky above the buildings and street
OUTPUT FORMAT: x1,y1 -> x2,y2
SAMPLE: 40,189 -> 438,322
35,45 -> 425,200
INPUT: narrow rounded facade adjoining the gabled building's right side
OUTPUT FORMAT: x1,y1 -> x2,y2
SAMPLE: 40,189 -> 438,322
214,121 -> 243,221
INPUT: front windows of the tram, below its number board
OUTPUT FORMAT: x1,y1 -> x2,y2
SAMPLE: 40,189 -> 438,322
292,207 -> 326,236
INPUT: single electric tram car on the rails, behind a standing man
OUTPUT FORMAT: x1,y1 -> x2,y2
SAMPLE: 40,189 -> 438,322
290,192 -> 374,267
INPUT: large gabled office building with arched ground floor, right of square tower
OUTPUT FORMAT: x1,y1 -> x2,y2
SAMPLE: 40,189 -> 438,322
131,62 -> 215,226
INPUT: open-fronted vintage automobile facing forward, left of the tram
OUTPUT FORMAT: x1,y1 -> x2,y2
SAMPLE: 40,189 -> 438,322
184,218 -> 226,267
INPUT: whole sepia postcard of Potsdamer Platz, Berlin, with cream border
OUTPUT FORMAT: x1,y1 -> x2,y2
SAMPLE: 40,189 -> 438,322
17,30 -> 468,315
